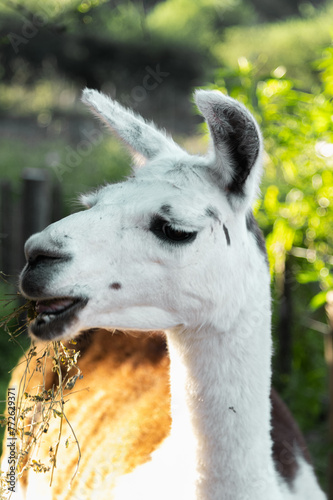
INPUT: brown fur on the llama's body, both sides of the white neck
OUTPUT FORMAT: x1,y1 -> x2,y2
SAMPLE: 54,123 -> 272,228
4,330 -> 310,500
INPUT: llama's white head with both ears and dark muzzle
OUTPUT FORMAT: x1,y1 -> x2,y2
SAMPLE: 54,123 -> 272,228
20,90 -> 269,339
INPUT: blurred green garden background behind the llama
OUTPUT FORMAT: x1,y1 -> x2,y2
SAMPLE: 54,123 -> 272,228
0,0 -> 333,500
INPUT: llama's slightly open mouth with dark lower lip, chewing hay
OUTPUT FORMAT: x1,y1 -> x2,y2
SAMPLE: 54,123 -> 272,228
29,297 -> 88,340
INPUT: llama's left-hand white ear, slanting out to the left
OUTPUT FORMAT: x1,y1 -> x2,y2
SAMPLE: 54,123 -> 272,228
82,89 -> 177,166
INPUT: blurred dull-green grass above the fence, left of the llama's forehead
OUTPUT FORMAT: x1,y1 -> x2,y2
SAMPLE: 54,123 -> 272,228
0,134 -> 130,206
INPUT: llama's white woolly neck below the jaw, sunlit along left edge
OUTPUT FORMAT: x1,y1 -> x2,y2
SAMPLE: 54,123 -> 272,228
168,294 -> 279,500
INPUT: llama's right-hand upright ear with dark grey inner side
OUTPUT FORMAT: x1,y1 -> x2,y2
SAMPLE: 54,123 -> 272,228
195,90 -> 262,206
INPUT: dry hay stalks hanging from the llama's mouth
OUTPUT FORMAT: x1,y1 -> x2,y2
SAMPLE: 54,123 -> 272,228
0,284 -> 82,500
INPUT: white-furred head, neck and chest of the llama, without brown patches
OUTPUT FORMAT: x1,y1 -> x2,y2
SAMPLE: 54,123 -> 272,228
5,89 -> 325,500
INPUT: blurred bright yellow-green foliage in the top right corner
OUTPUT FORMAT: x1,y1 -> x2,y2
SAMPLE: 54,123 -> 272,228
212,2 -> 333,89
